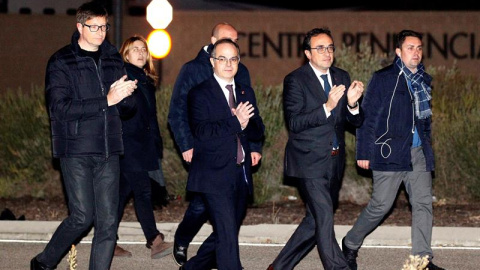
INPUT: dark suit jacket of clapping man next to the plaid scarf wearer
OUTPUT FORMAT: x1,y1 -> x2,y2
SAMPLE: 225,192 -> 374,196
283,63 -> 363,178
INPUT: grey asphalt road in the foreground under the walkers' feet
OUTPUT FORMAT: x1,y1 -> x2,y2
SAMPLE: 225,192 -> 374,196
4,241 -> 480,270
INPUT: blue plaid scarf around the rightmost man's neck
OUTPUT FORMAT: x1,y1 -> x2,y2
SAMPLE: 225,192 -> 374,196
395,57 -> 432,119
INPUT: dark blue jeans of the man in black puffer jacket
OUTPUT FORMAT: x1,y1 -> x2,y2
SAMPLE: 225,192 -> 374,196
37,156 -> 120,270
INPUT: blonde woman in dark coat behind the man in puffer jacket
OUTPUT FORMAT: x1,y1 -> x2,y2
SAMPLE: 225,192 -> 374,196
115,35 -> 172,259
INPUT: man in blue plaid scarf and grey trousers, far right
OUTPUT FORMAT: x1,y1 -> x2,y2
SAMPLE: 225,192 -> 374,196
342,30 -> 445,270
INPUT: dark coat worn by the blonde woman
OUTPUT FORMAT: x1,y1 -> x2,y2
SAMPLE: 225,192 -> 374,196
120,63 -> 163,172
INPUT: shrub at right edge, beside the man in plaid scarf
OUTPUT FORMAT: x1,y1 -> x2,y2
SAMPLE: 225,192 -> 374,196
429,66 -> 480,202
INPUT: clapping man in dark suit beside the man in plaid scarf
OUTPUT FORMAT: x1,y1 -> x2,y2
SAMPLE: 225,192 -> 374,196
268,28 -> 363,270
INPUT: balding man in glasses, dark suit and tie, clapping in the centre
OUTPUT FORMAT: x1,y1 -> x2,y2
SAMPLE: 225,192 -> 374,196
180,39 -> 265,270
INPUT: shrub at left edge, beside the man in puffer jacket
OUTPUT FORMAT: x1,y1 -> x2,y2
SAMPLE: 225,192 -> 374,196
0,86 -> 61,197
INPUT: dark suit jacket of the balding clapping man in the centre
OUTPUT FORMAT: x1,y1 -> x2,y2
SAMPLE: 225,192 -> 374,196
187,75 -> 265,194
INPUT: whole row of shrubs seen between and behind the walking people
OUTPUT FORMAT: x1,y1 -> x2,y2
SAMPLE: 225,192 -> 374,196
0,48 -> 480,204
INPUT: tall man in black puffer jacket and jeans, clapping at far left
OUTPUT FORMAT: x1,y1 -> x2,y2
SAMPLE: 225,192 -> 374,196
30,1 -> 137,270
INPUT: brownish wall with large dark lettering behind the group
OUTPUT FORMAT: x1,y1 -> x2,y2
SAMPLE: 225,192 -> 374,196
0,11 -> 480,91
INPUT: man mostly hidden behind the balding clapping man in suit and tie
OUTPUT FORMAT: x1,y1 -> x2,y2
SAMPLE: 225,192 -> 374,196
168,22 -> 262,266
